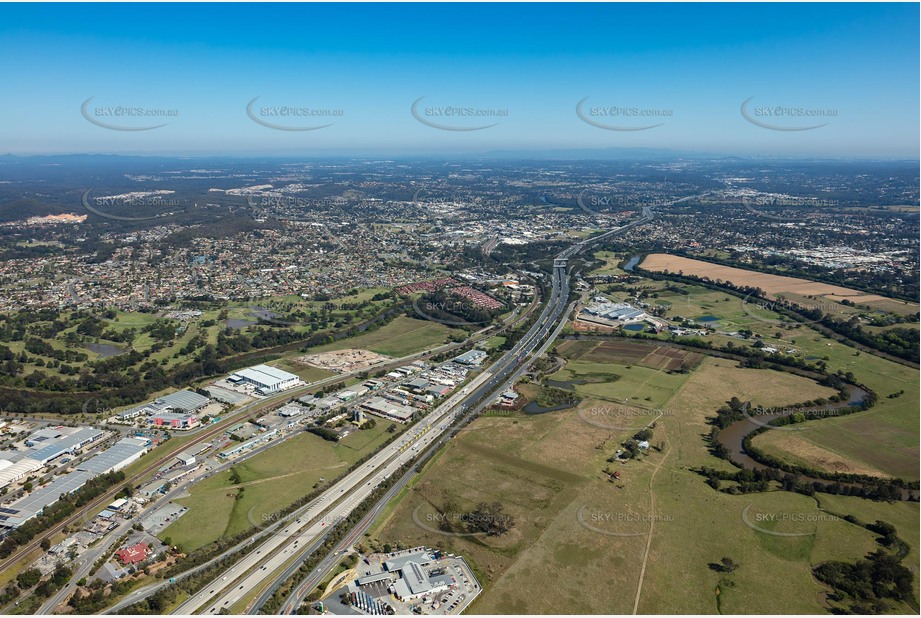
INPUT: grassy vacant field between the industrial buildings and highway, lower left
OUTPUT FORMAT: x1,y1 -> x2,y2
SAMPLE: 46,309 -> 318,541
159,422 -> 392,551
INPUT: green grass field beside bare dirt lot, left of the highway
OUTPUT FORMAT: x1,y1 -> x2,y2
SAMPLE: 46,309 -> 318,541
309,316 -> 463,357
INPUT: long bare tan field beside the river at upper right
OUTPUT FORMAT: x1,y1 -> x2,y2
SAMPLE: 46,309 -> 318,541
641,253 -> 918,313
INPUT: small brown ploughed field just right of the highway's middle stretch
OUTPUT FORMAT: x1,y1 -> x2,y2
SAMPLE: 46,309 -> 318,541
560,341 -> 704,371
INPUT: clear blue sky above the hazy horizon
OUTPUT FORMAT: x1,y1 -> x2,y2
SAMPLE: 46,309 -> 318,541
0,4 -> 919,159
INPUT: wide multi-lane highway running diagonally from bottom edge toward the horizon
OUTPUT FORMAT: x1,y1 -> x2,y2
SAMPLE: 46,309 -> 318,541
102,208 -> 652,614
